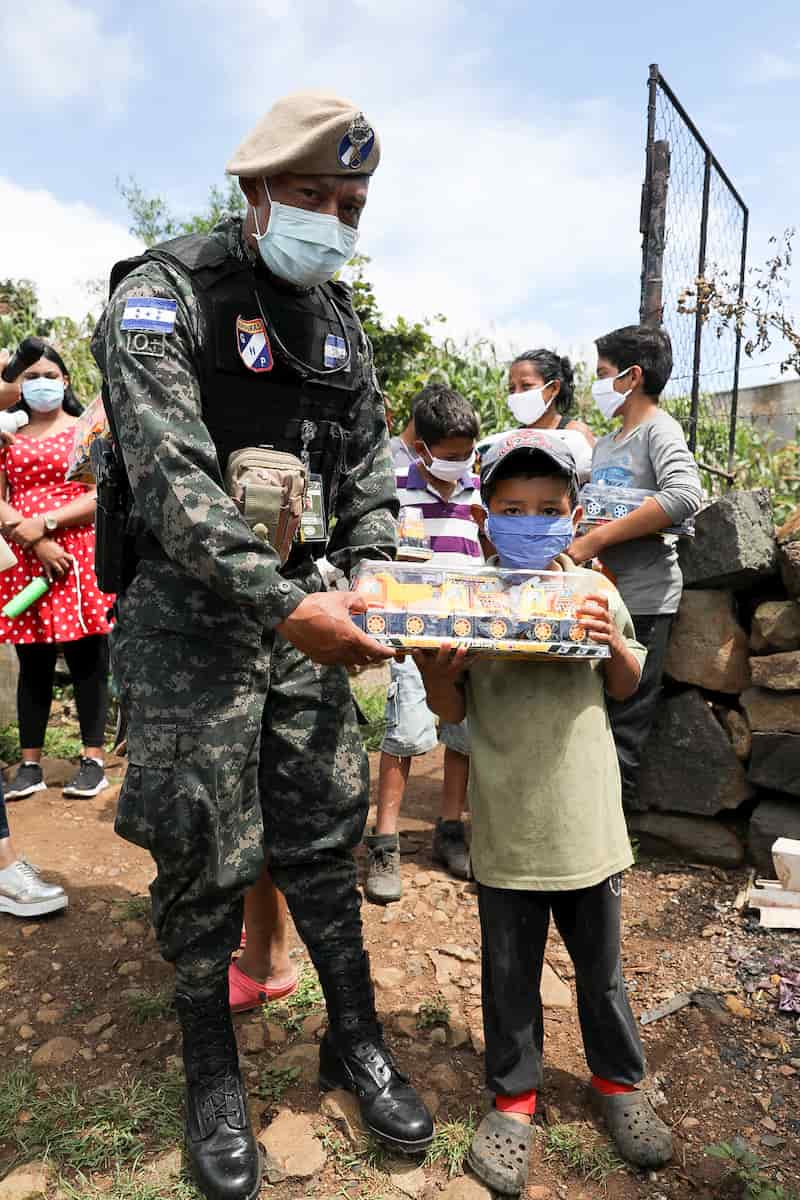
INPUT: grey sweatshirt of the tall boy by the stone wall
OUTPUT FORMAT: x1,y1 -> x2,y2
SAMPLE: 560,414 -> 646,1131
591,408 -> 703,616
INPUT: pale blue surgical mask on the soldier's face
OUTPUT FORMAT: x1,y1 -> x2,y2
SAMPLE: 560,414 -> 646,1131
253,180 -> 359,288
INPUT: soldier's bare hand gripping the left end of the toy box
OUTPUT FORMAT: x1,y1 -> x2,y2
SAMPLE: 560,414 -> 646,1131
276,592 -> 395,667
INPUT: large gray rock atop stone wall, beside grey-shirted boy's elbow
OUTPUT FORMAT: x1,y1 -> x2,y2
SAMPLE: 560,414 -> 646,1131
679,487 -> 777,589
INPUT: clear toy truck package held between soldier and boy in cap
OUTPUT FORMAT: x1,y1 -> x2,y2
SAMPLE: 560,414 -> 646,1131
353,562 -> 610,660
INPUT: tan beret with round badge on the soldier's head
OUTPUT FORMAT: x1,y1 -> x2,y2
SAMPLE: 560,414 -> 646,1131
225,91 -> 380,178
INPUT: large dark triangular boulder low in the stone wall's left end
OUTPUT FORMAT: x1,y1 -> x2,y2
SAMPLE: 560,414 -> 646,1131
636,689 -> 751,816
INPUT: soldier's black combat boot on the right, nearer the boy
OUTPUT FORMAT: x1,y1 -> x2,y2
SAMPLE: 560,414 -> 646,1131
319,953 -> 433,1154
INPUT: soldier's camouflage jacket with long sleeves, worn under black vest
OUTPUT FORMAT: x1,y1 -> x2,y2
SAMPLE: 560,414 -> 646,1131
92,221 -> 397,641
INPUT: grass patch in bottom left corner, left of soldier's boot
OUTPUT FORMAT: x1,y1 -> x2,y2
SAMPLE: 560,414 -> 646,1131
0,1070 -> 184,1174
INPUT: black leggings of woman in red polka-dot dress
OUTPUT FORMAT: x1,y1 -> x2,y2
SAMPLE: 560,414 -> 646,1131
17,634 -> 108,750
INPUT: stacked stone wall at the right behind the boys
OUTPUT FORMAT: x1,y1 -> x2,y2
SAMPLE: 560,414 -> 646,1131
628,490 -> 800,875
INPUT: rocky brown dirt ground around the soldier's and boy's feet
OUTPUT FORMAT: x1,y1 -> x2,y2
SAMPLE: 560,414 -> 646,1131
0,754 -> 800,1200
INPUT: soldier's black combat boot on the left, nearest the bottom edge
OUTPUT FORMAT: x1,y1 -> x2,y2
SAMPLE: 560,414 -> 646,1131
175,979 -> 261,1200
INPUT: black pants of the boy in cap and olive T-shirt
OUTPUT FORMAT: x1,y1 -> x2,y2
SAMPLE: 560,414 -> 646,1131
477,875 -> 644,1096
